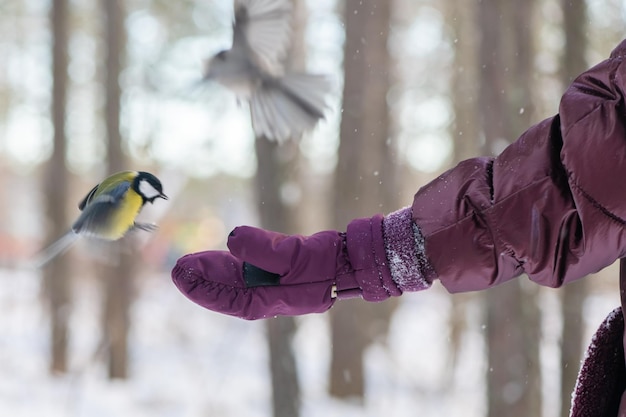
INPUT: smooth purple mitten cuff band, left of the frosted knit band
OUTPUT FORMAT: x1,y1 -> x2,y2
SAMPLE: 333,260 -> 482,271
346,215 -> 402,301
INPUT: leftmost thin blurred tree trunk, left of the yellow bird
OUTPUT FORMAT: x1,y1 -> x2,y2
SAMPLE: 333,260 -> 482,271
44,0 -> 71,372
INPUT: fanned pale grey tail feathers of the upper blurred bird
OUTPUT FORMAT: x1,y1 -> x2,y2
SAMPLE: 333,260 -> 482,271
250,73 -> 332,142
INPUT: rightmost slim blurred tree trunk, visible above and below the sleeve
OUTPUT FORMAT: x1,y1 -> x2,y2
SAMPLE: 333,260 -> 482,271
561,0 -> 587,417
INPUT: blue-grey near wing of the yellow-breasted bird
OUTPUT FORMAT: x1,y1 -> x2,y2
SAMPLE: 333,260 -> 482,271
72,181 -> 130,236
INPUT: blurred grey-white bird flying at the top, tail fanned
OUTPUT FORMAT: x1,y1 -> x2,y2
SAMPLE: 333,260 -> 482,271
203,0 -> 331,141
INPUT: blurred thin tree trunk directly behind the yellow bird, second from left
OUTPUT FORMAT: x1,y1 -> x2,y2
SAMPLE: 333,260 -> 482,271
102,0 -> 135,378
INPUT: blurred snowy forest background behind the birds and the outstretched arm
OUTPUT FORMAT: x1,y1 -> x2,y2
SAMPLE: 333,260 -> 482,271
0,0 -> 626,417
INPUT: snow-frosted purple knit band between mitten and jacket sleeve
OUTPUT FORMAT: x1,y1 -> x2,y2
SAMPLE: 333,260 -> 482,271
383,207 -> 436,291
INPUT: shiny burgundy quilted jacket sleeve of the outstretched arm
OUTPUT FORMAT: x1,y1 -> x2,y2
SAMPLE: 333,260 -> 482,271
411,41 -> 626,292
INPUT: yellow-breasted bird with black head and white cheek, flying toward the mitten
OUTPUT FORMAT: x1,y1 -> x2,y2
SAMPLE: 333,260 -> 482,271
34,171 -> 168,267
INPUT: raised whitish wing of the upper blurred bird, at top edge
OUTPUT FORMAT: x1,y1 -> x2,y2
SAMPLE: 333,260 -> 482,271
233,0 -> 291,75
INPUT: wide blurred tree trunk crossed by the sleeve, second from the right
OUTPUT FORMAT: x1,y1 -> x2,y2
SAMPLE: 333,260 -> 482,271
477,0 -> 541,417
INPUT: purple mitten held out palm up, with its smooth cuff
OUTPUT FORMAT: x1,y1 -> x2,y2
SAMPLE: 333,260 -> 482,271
172,210 -> 428,320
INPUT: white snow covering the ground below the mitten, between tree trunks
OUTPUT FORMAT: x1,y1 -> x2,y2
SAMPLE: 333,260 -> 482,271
0,270 -> 612,417
